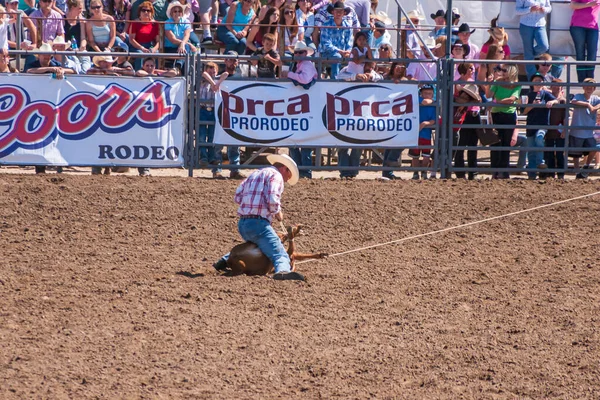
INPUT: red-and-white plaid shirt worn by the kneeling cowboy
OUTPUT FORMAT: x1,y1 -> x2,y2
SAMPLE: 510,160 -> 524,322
234,167 -> 283,222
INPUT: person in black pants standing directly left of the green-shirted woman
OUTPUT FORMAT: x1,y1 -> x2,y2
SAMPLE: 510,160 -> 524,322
454,63 -> 481,180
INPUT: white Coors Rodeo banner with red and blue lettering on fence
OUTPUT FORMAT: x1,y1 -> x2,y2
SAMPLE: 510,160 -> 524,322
0,75 -> 185,167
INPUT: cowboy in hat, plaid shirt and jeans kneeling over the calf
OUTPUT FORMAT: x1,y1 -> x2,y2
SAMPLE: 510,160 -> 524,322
213,154 -> 304,281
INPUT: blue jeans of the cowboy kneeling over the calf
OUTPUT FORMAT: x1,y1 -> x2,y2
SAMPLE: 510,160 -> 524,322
223,218 -> 292,273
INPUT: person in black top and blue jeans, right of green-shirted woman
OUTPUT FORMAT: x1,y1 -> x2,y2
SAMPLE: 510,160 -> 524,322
523,73 -> 558,180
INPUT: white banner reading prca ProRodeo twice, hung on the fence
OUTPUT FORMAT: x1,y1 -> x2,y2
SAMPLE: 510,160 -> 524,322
215,81 -> 419,147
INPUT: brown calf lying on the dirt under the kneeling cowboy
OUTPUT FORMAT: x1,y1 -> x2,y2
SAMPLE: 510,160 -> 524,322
227,225 -> 327,275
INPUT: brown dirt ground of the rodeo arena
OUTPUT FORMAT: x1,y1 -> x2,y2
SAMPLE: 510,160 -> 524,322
0,174 -> 600,399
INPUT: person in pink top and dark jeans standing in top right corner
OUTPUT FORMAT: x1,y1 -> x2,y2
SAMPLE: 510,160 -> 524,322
569,0 -> 600,82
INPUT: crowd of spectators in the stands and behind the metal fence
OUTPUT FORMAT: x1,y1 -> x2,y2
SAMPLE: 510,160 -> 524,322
0,0 -> 600,179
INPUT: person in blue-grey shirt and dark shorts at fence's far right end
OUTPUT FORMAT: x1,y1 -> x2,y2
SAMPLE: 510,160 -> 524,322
569,78 -> 600,179
